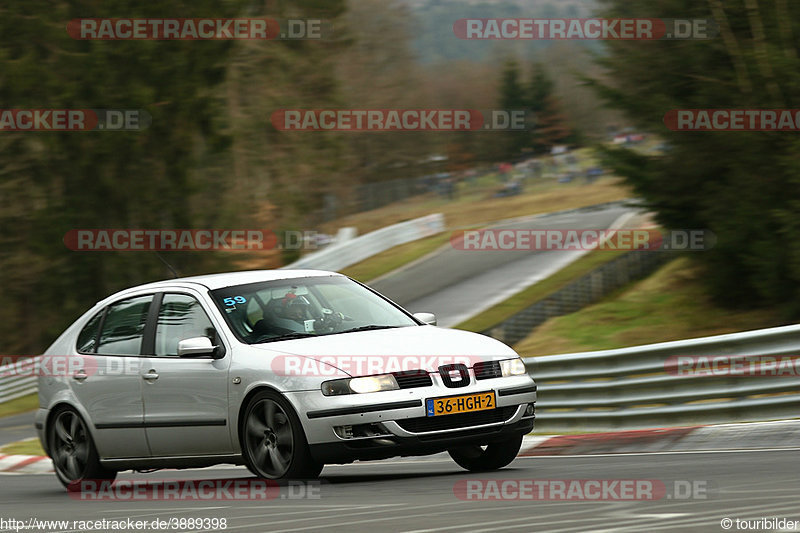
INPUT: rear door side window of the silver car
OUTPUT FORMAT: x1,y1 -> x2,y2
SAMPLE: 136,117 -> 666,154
97,295 -> 153,355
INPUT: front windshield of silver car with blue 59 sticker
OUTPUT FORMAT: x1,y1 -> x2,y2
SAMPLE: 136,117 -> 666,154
206,276 -> 418,344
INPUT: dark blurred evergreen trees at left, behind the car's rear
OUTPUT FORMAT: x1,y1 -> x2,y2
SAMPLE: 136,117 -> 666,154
0,0 -> 243,354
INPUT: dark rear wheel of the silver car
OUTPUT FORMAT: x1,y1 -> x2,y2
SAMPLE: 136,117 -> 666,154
47,407 -> 117,490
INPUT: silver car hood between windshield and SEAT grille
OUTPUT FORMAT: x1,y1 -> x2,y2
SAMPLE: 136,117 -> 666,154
253,326 -> 517,376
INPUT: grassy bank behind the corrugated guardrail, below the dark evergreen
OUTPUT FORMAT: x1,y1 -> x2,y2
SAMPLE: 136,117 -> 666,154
515,257 -> 785,357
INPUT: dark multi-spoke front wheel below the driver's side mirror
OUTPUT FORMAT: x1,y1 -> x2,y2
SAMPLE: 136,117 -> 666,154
241,390 -> 325,480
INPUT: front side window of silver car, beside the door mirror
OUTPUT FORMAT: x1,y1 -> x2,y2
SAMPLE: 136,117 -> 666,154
156,294 -> 216,356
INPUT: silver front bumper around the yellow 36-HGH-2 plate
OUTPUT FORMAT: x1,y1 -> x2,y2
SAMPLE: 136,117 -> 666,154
287,376 -> 536,463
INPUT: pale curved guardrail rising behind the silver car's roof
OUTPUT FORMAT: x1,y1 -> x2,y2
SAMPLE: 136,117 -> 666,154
282,213 -> 444,270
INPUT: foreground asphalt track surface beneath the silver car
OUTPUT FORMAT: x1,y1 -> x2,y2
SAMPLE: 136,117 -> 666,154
0,449 -> 800,533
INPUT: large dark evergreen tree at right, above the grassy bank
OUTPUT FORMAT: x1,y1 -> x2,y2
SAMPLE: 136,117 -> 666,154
595,0 -> 800,316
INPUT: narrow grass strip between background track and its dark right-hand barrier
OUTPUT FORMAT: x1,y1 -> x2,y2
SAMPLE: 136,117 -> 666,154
455,250 -> 625,332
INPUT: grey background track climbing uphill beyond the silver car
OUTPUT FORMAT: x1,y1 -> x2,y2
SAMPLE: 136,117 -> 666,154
370,204 -> 636,327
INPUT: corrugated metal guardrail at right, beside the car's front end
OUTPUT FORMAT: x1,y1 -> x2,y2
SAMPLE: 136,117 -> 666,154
525,325 -> 800,432
